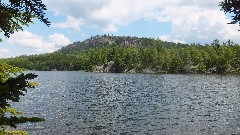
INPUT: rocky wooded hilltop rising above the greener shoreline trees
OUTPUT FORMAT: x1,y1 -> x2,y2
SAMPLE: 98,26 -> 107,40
57,35 -> 187,53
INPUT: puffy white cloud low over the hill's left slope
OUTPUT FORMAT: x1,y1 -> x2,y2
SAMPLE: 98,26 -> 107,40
7,30 -> 70,53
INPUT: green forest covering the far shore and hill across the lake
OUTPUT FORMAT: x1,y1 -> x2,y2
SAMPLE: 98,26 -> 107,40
0,35 -> 240,73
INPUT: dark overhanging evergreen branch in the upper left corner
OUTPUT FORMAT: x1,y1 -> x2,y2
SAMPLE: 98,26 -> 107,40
0,0 -> 50,41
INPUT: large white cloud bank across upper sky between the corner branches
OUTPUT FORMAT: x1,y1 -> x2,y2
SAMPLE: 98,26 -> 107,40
44,0 -> 240,43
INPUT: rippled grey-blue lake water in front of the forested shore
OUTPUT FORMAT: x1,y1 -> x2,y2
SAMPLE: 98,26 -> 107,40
13,71 -> 240,135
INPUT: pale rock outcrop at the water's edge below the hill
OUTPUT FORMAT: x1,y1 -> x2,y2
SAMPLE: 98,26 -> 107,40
93,61 -> 115,73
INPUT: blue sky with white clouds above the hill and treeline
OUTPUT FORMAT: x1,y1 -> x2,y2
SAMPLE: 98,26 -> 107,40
0,0 -> 240,58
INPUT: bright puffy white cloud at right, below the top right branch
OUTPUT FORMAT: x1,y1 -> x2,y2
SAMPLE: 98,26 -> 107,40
149,6 -> 240,43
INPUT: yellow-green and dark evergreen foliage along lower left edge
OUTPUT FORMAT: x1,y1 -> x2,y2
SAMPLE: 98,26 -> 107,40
0,63 -> 44,134
